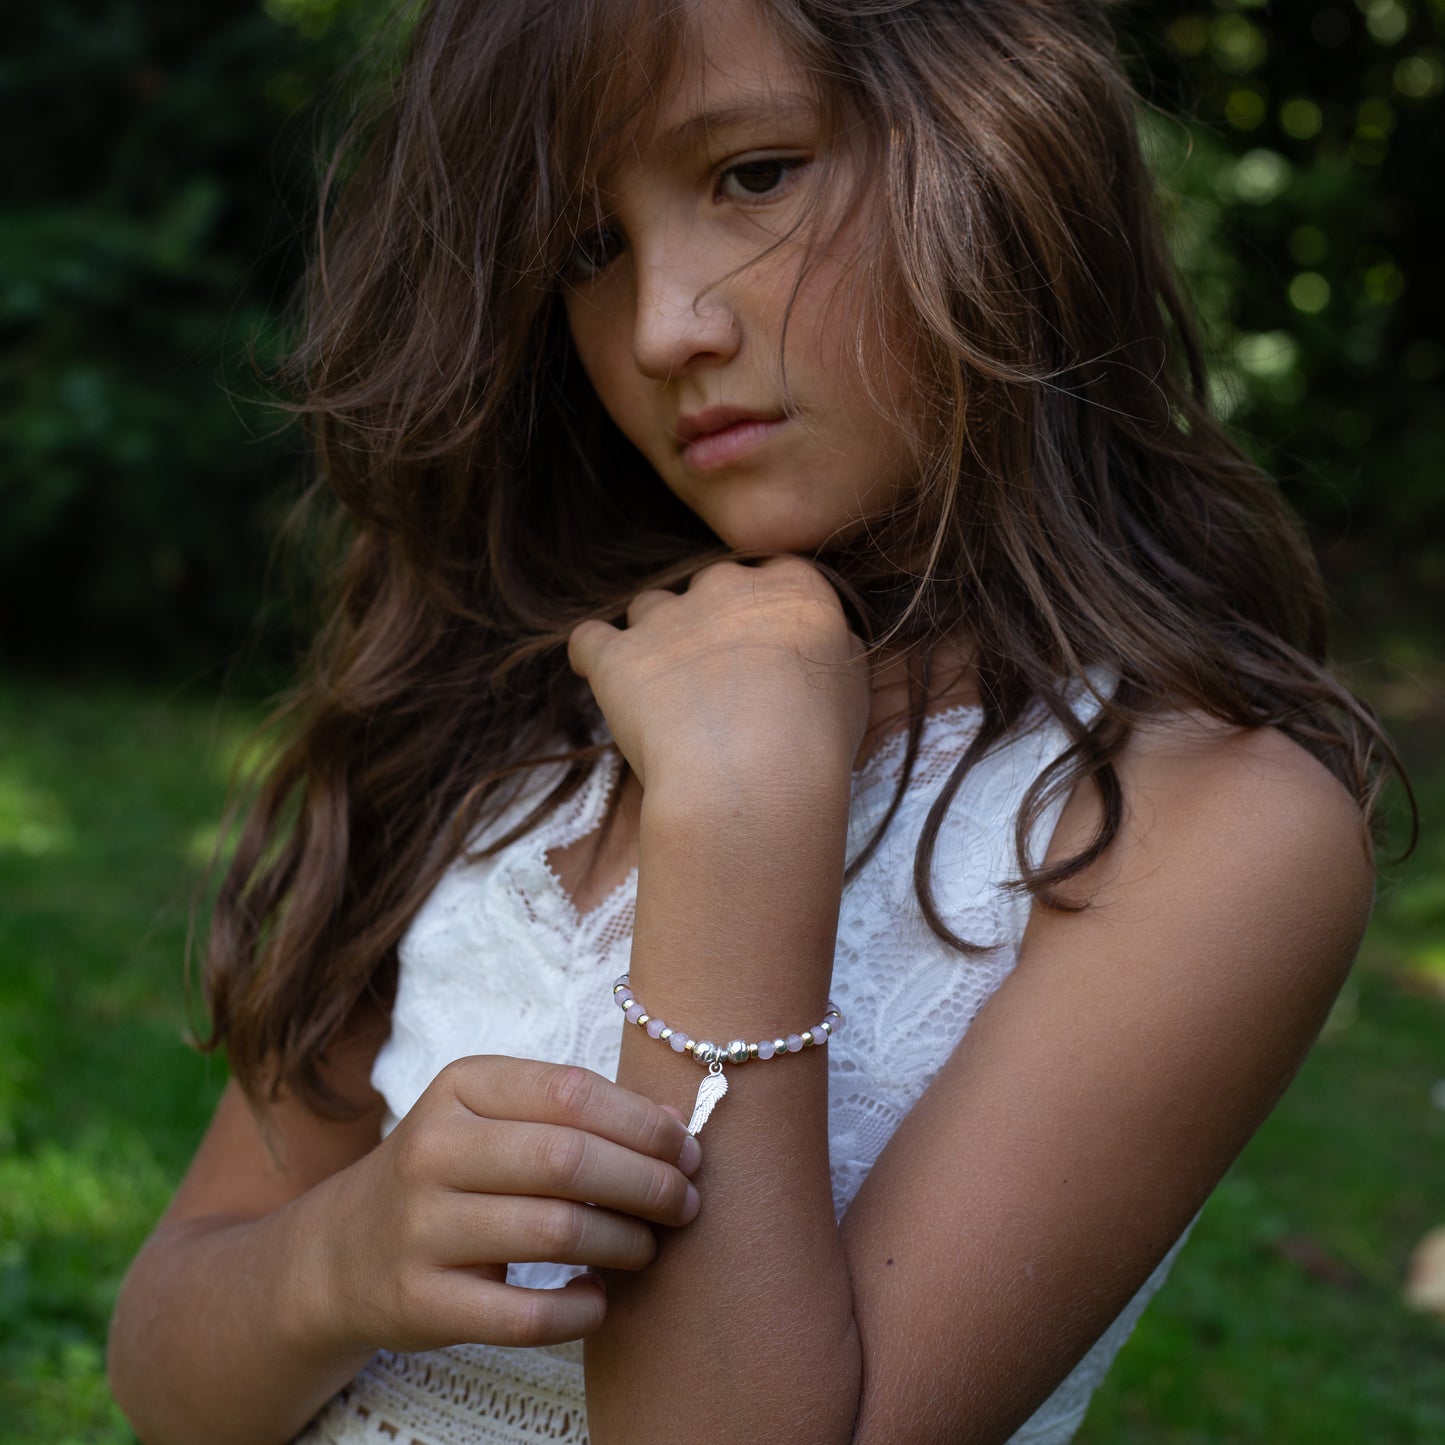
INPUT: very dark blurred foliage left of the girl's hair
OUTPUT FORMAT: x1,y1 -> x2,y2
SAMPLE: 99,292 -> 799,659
0,0 -> 390,668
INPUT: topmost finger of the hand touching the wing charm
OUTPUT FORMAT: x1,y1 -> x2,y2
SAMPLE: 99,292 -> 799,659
438,1055 -> 692,1163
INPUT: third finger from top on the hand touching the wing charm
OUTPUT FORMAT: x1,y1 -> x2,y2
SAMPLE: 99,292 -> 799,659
442,1194 -> 657,1270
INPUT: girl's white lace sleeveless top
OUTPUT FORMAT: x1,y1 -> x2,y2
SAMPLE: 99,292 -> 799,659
296,675 -> 1188,1445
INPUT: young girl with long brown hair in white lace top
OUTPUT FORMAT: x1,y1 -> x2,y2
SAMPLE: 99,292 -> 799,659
111,0 -> 1386,1445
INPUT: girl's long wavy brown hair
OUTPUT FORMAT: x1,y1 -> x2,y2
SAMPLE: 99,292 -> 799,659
207,0 -> 1393,1108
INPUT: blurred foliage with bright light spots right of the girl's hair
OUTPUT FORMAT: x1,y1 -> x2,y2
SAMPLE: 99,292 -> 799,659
1124,0 -> 1445,626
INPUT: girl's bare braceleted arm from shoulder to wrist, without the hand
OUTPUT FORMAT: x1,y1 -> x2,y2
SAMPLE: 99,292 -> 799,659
572,563 -> 1370,1445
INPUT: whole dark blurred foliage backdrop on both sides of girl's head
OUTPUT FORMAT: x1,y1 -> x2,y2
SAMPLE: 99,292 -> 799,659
0,0 -> 1445,670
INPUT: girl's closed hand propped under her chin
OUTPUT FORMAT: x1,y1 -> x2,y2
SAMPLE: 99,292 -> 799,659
568,556 -> 868,789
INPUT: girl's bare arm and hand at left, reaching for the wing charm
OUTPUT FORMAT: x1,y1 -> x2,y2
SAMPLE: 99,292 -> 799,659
110,1017 -> 695,1445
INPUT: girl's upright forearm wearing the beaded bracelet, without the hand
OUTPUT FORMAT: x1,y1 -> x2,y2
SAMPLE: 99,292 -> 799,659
587,766 -> 860,1445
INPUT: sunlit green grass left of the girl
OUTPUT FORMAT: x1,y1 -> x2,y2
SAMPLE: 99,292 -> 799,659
0,685 -> 250,1445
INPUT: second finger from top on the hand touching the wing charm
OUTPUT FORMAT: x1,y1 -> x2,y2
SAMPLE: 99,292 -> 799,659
435,1113 -> 698,1225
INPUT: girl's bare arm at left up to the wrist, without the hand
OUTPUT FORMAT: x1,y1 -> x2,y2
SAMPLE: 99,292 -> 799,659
108,1027 -> 395,1445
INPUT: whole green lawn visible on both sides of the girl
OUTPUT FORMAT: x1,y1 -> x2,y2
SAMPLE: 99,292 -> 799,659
0,683 -> 1445,1445
